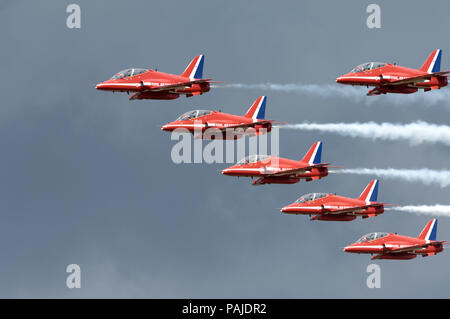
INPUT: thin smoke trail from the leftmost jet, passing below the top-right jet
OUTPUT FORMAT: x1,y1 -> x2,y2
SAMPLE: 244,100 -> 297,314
214,83 -> 450,106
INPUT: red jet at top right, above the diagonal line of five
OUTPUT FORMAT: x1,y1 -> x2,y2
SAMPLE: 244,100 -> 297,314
336,49 -> 450,95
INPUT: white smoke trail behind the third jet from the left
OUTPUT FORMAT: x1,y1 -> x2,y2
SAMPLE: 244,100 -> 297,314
336,168 -> 450,187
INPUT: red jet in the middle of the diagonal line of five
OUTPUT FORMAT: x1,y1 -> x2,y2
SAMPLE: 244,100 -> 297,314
222,142 -> 330,185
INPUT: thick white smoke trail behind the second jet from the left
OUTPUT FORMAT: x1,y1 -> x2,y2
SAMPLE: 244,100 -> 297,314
278,121 -> 450,146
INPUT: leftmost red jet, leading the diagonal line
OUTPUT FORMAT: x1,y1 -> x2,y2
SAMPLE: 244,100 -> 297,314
95,55 -> 211,100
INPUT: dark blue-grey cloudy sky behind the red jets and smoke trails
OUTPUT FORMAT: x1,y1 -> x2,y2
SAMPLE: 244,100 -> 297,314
0,0 -> 450,298
